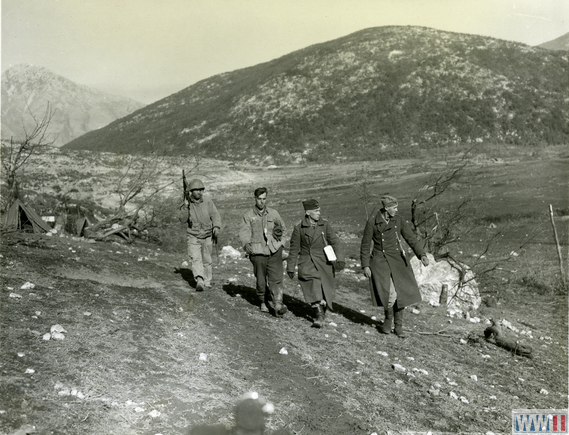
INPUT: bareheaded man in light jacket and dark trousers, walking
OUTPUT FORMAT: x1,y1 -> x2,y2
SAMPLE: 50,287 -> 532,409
239,187 -> 287,316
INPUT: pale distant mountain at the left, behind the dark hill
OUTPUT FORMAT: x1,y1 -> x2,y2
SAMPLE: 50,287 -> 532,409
2,64 -> 144,146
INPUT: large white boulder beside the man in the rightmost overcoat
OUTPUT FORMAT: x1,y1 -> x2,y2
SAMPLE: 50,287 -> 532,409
411,254 -> 482,312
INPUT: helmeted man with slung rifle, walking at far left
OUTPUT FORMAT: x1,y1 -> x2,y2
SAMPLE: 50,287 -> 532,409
180,178 -> 221,291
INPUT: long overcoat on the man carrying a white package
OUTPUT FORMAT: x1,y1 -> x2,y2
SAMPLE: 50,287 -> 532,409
287,216 -> 344,309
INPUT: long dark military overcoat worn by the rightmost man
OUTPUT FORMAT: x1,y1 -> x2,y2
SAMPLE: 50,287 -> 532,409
360,212 -> 425,308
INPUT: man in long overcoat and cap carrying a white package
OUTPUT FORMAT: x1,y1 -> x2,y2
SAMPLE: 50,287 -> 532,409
287,199 -> 345,328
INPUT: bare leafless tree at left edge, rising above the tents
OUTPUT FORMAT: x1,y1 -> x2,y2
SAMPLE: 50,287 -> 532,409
2,103 -> 57,208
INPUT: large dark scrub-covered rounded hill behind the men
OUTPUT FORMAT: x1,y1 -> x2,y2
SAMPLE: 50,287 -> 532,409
63,26 -> 569,163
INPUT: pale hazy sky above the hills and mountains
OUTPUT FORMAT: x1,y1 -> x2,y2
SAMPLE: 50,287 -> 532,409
1,0 -> 569,103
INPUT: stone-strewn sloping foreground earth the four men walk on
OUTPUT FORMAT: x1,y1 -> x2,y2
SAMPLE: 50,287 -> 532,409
0,230 -> 568,435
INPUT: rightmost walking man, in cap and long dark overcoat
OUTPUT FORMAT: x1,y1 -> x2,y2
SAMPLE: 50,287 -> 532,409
360,195 -> 429,337
